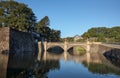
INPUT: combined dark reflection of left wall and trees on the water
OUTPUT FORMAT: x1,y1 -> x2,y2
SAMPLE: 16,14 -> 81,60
4,47 -> 60,78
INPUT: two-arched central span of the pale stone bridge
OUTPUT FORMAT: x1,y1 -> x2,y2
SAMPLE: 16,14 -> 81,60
38,42 -> 101,52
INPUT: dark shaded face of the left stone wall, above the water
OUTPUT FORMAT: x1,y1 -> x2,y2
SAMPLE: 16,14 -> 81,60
10,29 -> 35,56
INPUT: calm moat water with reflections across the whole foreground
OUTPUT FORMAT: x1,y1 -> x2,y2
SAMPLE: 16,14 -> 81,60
0,46 -> 120,78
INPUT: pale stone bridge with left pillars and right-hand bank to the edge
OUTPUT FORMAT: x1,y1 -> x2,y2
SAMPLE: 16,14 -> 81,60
38,42 -> 120,60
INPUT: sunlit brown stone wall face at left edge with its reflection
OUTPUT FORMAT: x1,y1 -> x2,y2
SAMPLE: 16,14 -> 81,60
0,28 -> 9,78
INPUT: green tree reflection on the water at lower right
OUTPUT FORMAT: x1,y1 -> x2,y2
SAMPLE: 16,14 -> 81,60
83,61 -> 120,75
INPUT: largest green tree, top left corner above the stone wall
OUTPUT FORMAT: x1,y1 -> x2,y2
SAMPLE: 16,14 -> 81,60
0,0 -> 36,31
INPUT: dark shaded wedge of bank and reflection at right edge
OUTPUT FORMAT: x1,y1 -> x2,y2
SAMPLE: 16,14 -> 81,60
103,49 -> 120,67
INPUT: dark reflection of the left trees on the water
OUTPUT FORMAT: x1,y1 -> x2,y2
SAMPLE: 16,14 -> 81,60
7,60 -> 60,78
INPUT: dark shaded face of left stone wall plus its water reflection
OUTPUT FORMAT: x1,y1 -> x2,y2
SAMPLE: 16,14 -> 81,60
8,29 -> 36,68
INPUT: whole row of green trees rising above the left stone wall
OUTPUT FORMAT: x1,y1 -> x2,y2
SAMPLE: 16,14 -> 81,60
0,0 -> 61,41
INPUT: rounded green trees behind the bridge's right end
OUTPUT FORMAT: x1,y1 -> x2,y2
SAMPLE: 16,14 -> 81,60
82,26 -> 120,42
